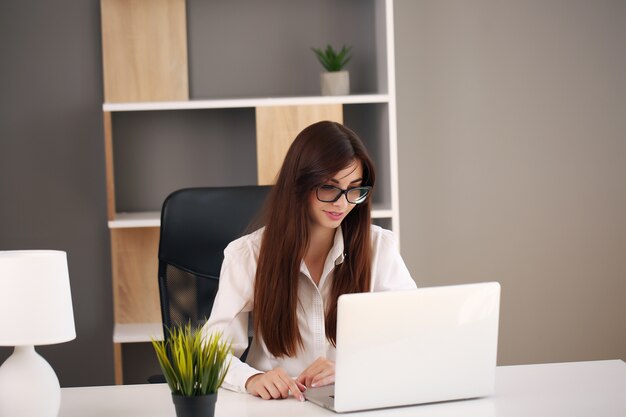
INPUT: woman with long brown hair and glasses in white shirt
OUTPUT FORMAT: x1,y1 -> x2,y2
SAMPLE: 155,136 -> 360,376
204,121 -> 415,401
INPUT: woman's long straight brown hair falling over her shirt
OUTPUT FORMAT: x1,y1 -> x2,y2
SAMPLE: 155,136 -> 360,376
254,121 -> 376,357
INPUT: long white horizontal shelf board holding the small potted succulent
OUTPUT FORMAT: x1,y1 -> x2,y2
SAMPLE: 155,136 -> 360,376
102,94 -> 389,112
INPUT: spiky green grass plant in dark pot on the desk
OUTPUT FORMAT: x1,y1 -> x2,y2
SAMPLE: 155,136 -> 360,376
152,324 -> 232,417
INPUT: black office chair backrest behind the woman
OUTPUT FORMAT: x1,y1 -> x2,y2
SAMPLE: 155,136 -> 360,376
159,186 -> 271,338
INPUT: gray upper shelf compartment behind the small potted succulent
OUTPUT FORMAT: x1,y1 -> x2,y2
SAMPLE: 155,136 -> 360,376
187,0 -> 382,98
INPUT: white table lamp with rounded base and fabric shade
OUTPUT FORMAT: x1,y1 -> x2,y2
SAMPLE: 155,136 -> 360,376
0,250 -> 76,417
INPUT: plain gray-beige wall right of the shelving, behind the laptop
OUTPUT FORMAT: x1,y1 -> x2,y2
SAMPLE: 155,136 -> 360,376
395,0 -> 626,364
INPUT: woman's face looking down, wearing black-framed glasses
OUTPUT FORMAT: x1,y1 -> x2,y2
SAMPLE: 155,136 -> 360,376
309,160 -> 363,229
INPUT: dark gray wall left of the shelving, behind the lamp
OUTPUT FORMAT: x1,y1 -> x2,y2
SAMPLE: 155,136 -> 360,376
0,0 -> 113,386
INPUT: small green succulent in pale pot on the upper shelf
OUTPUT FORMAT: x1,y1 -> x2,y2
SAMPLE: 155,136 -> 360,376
311,45 -> 352,96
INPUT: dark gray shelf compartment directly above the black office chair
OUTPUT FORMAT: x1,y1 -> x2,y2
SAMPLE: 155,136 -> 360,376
112,108 -> 257,212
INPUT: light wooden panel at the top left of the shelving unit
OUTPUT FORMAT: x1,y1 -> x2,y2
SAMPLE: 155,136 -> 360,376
100,0 -> 189,101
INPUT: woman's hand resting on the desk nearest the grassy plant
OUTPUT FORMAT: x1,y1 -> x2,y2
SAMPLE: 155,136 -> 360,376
246,368 -> 306,401
